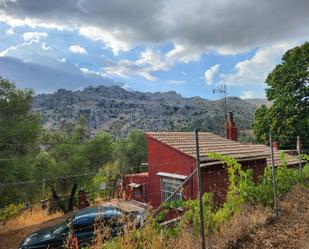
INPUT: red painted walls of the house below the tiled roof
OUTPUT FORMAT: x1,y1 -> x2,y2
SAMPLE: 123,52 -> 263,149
125,136 -> 266,208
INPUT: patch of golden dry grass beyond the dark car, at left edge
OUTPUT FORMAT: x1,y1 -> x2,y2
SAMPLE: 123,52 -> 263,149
0,207 -> 63,234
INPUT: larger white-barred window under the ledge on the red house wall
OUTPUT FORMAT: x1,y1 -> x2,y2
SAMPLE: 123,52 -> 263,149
161,176 -> 183,201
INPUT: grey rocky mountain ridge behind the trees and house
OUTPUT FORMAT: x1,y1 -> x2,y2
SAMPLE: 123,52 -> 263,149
33,86 -> 257,135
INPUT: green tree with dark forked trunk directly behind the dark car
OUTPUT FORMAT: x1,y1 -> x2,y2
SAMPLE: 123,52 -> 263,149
37,118 -> 90,212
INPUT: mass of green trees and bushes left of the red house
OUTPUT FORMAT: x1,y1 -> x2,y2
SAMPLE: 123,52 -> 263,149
0,78 -> 147,212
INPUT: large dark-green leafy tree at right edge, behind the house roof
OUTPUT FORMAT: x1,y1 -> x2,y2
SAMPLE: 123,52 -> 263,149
254,42 -> 309,143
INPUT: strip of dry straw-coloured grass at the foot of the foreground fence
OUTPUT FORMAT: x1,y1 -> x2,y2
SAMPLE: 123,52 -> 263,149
95,206 -> 272,249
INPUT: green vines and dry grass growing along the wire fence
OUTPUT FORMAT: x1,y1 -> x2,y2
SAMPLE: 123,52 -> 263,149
100,154 -> 309,249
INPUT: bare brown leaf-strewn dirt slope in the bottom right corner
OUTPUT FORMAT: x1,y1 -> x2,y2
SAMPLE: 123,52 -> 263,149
228,187 -> 309,249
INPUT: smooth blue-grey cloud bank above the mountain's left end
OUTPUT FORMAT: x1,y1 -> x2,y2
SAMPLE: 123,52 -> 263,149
0,57 -> 119,93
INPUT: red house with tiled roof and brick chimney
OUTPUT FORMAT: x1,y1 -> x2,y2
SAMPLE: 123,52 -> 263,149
125,116 -> 298,208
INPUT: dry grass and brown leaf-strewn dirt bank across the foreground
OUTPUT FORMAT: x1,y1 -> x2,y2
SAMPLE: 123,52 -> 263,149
95,186 -> 309,249
